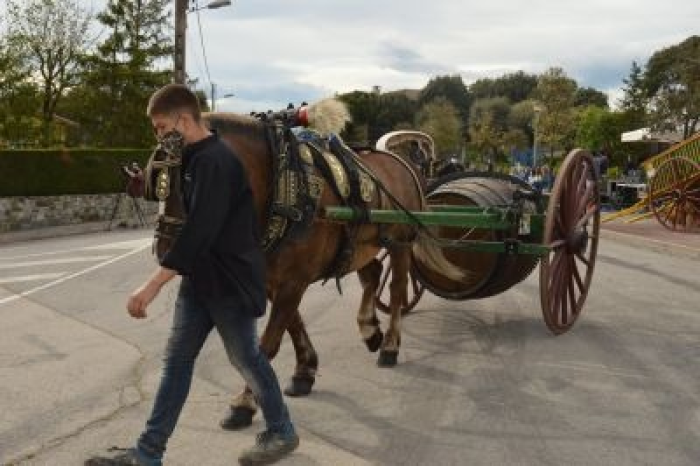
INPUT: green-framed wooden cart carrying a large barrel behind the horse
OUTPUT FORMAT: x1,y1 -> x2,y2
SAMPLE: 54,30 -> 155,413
322,150 -> 600,334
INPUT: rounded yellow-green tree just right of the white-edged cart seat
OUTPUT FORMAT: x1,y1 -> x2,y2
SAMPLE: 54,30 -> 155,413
416,97 -> 462,156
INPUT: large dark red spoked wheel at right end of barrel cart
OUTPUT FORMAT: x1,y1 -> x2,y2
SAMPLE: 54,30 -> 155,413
540,149 -> 600,334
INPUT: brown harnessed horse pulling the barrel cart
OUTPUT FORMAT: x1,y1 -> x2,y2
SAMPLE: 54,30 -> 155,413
148,101 -> 461,425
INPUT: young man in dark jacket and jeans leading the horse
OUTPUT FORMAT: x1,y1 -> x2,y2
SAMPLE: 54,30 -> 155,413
85,84 -> 299,466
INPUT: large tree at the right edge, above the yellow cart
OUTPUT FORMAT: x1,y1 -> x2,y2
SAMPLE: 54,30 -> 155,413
644,36 -> 700,137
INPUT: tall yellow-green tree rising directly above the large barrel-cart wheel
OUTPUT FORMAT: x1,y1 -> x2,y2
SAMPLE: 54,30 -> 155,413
535,68 -> 577,162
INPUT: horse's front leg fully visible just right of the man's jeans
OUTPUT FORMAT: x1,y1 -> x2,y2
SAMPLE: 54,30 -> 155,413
284,310 -> 318,396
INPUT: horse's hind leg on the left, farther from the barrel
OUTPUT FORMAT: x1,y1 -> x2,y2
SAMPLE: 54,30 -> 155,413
357,259 -> 384,353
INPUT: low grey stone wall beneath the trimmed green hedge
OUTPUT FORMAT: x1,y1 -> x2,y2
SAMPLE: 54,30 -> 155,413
0,194 -> 158,234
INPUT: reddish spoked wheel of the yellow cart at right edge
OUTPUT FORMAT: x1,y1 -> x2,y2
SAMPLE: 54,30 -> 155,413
648,157 -> 700,231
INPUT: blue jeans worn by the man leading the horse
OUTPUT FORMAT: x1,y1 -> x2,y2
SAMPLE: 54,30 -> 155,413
138,278 -> 294,458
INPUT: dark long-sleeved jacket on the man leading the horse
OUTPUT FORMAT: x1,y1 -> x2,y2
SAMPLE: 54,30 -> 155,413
161,134 -> 266,317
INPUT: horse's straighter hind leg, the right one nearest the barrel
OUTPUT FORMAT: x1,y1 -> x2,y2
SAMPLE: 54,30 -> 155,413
377,246 -> 411,367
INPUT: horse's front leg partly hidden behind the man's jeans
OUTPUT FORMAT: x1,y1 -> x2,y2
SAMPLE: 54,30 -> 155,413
221,286 -> 306,430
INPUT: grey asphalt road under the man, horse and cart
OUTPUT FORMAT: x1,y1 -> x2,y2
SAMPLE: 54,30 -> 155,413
0,230 -> 700,466
